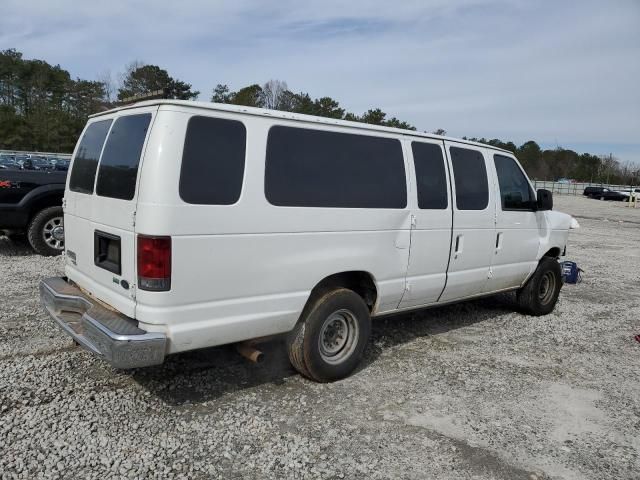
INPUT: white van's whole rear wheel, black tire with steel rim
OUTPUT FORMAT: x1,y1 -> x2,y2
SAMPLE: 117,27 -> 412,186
287,288 -> 371,382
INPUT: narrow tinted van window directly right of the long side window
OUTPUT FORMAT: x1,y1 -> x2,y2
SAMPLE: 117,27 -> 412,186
411,142 -> 449,209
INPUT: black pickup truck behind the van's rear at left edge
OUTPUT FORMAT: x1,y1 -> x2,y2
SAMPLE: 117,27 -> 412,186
0,155 -> 68,255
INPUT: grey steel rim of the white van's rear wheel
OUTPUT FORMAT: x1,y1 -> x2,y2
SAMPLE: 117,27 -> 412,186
318,308 -> 360,365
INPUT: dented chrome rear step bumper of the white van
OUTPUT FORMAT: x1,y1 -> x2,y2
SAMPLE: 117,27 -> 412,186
40,277 -> 167,369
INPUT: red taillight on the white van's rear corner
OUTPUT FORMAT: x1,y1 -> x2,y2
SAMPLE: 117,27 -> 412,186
138,235 -> 171,292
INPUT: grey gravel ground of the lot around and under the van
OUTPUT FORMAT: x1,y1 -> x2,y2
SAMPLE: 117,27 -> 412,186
0,197 -> 640,480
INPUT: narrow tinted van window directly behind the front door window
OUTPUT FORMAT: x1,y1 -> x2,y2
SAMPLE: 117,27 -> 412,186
449,147 -> 489,210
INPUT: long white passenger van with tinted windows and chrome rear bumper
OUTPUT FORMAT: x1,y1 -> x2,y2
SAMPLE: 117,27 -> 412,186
40,100 -> 575,381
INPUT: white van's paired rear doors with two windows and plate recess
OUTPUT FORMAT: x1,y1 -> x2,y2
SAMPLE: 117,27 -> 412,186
64,107 -> 157,317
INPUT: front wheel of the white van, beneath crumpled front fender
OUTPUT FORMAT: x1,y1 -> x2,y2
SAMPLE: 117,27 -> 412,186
516,257 -> 562,316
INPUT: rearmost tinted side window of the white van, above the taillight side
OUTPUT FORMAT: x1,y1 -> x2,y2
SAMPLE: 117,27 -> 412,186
180,117 -> 247,205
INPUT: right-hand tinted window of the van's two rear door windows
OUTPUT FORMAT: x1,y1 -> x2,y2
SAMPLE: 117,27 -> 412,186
96,113 -> 151,200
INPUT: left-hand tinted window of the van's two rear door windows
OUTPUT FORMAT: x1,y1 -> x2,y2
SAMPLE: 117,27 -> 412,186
69,120 -> 111,193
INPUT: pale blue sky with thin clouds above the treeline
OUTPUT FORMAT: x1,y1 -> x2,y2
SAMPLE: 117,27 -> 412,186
0,0 -> 640,163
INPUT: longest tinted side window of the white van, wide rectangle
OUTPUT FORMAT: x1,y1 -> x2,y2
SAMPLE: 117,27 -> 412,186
264,126 -> 407,208
